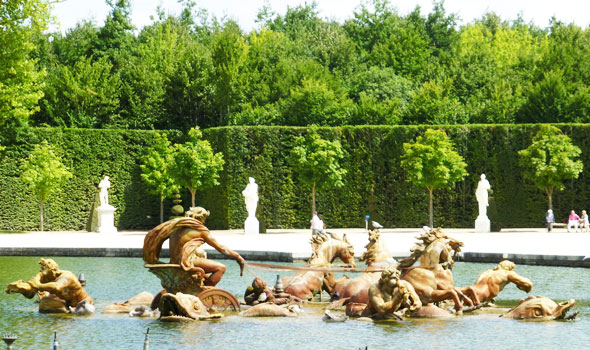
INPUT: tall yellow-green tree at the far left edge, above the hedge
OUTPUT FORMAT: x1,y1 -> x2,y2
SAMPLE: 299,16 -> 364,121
0,0 -> 51,143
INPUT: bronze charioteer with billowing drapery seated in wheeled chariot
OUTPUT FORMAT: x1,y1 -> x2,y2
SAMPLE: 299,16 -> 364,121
143,207 -> 245,316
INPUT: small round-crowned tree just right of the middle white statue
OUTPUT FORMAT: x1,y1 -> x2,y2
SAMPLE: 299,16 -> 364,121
289,127 -> 346,213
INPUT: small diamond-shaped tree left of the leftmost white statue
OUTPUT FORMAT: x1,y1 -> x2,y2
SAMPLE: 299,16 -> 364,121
20,140 -> 72,231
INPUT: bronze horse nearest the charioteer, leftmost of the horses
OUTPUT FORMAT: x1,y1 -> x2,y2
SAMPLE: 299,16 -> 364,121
282,234 -> 356,300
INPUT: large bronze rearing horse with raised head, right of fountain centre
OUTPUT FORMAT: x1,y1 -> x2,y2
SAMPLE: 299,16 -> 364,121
399,228 -> 477,310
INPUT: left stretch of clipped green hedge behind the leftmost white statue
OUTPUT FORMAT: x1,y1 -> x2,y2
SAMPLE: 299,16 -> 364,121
0,128 -> 180,231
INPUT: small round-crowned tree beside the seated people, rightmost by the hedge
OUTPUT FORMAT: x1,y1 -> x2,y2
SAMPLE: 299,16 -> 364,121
518,125 -> 584,209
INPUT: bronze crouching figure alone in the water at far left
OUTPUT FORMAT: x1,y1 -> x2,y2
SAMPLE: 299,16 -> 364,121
6,259 -> 94,315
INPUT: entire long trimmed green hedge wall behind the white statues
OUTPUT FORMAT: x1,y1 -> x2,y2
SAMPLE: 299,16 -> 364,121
0,124 -> 590,230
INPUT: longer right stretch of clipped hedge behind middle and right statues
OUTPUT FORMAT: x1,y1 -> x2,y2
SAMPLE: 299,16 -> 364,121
201,124 -> 590,228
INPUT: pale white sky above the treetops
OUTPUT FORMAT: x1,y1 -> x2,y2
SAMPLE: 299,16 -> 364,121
53,0 -> 590,32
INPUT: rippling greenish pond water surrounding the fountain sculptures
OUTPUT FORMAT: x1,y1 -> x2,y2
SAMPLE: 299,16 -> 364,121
0,257 -> 590,350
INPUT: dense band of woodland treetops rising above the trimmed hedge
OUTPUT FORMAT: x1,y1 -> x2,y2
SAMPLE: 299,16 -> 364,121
0,0 -> 590,135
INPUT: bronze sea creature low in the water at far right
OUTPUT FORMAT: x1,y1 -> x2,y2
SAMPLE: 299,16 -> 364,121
502,295 -> 578,321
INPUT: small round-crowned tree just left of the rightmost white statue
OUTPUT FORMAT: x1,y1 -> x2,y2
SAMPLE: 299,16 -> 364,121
401,129 -> 467,227
